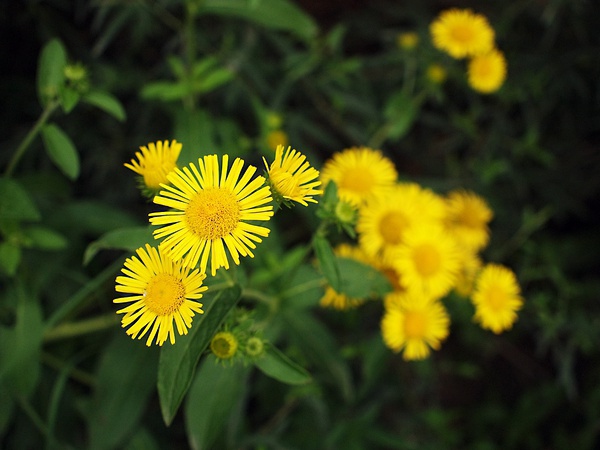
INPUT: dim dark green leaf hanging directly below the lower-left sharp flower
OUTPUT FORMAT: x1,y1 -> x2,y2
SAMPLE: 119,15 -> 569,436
88,330 -> 158,450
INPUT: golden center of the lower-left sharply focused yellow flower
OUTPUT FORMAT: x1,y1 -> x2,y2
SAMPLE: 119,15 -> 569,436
144,273 -> 185,316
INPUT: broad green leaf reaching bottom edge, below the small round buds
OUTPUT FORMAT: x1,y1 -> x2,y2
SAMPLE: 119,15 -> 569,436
185,355 -> 249,449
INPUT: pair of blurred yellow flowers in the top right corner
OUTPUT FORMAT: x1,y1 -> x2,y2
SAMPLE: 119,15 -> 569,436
430,8 -> 506,94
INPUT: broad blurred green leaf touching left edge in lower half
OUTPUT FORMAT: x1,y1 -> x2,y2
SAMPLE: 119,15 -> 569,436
0,285 -> 43,397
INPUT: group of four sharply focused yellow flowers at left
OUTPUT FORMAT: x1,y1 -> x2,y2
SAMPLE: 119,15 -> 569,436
114,141 -> 321,348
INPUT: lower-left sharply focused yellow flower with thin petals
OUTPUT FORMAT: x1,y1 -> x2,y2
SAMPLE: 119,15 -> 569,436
113,244 -> 207,346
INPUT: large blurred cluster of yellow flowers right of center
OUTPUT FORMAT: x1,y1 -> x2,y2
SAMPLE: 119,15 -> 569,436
321,148 -> 522,360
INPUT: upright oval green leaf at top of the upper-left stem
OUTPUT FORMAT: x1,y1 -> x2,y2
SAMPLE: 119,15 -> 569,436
37,39 -> 67,106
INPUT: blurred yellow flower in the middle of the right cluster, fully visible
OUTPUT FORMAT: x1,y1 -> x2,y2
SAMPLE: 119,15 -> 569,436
394,226 -> 460,297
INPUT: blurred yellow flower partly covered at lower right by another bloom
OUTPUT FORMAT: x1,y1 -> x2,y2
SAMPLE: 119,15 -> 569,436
356,183 -> 446,264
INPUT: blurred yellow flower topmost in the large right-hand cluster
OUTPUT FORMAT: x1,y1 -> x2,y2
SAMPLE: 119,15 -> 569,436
321,147 -> 398,206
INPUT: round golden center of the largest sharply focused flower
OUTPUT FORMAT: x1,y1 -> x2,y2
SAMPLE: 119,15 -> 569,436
185,188 -> 240,241
